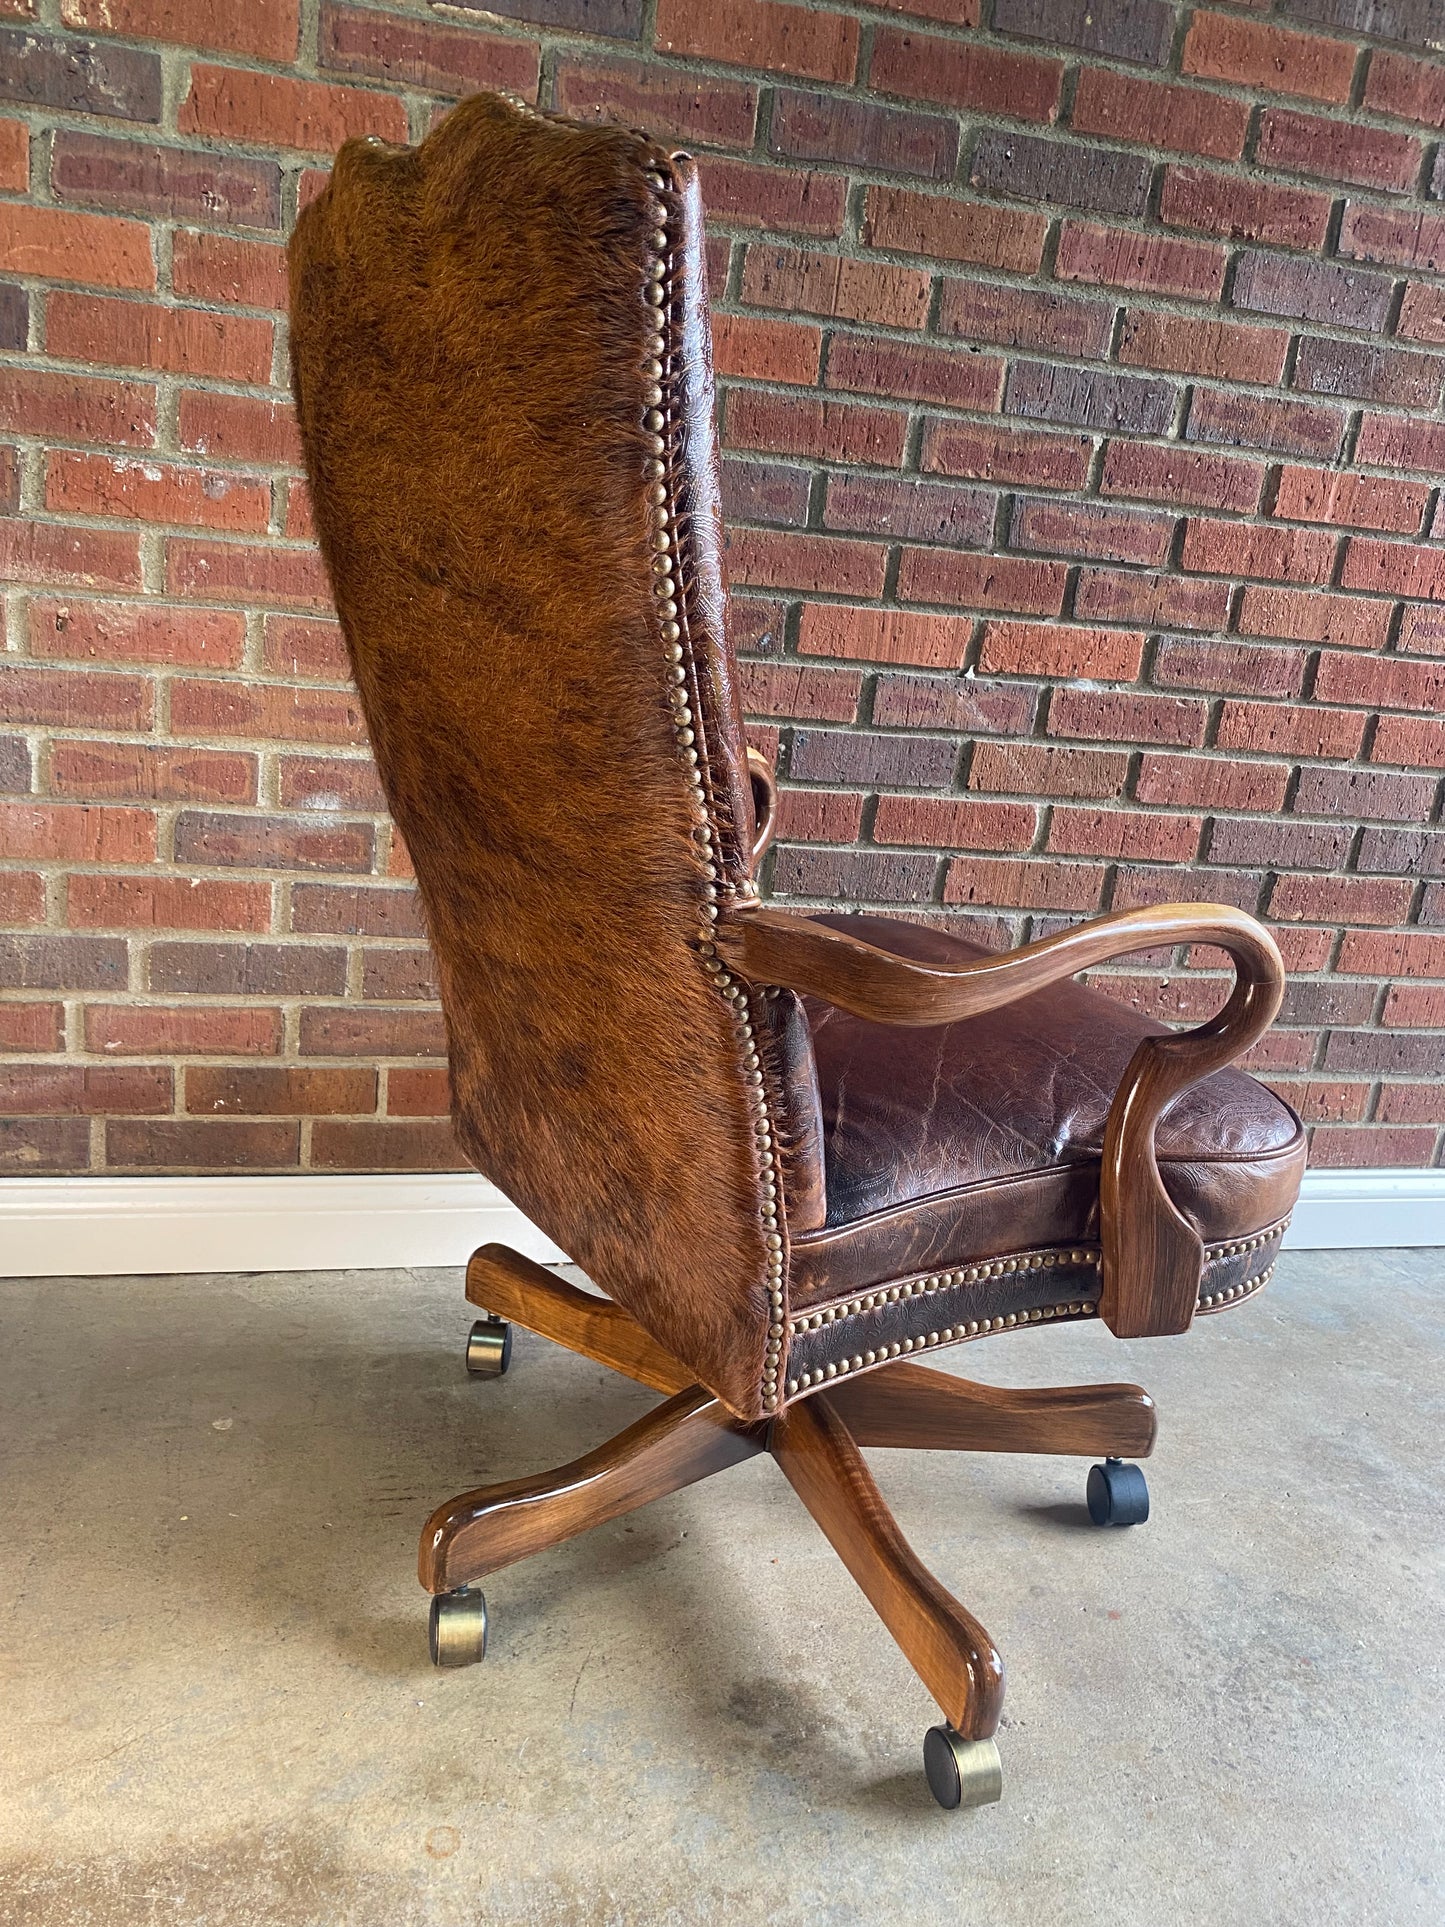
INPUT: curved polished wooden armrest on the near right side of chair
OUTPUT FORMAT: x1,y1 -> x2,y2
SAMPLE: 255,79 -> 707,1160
715,904 -> 1285,1337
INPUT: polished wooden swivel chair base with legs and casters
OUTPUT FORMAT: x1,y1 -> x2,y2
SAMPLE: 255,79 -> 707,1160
418,1245 -> 1154,1806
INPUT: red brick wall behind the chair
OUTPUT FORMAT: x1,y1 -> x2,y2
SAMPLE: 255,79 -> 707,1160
0,0 -> 1445,1172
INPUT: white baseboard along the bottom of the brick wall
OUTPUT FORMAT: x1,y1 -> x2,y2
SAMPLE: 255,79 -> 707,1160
0,1172 -> 1445,1278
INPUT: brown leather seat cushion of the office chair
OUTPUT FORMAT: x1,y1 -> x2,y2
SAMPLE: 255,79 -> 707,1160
792,915 -> 1304,1303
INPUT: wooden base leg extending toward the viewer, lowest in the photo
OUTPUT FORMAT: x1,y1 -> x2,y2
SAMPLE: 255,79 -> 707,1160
769,1382 -> 1004,1740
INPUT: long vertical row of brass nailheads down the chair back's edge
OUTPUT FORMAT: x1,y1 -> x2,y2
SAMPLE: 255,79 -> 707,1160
642,170 -> 786,1412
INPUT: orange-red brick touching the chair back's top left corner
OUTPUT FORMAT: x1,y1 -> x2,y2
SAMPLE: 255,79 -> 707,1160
175,62 -> 407,154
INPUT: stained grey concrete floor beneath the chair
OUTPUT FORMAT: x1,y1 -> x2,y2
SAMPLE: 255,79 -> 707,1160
0,1253 -> 1445,1927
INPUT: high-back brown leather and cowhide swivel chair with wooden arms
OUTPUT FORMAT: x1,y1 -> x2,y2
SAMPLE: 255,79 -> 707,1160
291,94 -> 1304,1806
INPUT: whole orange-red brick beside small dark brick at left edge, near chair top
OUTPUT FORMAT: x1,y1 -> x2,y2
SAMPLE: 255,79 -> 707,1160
44,291 -> 272,382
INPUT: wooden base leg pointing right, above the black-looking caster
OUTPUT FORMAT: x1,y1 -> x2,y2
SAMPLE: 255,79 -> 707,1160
828,1360 -> 1158,1459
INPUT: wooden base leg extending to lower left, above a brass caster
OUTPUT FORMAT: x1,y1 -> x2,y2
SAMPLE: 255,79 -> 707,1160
418,1386 -> 767,1594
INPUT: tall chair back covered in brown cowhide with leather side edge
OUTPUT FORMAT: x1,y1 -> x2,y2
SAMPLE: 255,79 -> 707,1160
291,94 -> 815,1416
